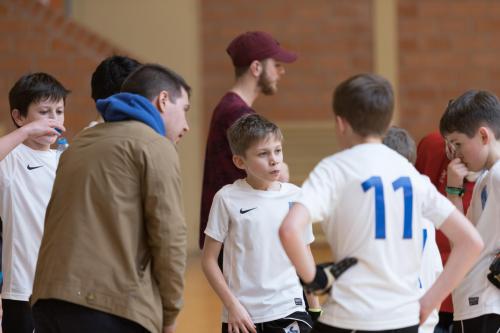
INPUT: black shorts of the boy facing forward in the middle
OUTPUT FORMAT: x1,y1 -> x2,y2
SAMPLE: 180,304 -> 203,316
222,311 -> 312,333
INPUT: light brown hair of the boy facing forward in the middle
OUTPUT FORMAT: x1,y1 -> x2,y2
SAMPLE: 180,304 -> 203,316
227,113 -> 283,156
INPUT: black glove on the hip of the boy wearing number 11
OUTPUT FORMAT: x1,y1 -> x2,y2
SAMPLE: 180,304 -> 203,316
300,258 -> 358,296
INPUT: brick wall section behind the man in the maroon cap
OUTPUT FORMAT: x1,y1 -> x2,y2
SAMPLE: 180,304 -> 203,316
201,0 -> 373,125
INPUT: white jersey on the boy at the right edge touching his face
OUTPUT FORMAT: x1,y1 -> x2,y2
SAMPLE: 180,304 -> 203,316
453,162 -> 500,320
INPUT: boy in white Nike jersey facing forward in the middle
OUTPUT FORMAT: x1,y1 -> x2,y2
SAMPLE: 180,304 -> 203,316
202,114 -> 354,332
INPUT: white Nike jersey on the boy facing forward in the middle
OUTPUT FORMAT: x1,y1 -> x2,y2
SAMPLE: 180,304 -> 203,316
205,179 -> 314,323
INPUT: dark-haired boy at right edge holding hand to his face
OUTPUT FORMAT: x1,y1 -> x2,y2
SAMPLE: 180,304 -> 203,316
440,90 -> 500,333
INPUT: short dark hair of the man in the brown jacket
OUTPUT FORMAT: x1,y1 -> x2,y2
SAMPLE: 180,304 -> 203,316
121,64 -> 191,102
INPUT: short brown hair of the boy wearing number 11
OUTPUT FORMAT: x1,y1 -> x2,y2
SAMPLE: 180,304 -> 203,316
333,74 -> 394,137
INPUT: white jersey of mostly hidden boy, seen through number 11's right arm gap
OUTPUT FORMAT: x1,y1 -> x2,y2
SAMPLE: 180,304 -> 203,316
418,219 -> 443,333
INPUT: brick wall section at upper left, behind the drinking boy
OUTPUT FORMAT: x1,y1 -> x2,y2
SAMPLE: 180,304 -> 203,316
0,0 -> 123,137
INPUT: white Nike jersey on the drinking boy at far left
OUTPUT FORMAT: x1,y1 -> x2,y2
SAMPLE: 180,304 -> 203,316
0,144 -> 59,301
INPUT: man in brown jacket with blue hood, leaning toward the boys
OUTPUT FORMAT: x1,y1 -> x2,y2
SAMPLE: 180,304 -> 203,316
31,64 -> 191,333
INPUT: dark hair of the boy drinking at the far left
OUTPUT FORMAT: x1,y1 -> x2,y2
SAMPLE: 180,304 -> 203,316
9,73 -> 70,127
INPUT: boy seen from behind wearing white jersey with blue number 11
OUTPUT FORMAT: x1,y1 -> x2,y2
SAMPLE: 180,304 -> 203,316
280,74 -> 482,332
